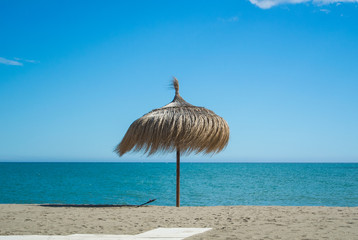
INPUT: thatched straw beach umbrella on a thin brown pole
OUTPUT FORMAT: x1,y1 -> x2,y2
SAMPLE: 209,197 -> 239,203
115,78 -> 230,207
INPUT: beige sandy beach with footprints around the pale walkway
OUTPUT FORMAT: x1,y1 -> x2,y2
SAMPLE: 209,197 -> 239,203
0,204 -> 358,240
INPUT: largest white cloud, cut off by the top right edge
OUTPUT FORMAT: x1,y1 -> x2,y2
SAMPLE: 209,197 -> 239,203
249,0 -> 358,9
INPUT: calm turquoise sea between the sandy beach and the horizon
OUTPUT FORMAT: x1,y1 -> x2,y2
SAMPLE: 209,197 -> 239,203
0,163 -> 358,206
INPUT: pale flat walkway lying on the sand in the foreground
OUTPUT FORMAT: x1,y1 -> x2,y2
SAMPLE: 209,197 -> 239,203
0,228 -> 211,240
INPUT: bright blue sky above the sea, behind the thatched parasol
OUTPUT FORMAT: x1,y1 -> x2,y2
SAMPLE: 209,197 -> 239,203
0,0 -> 358,162
